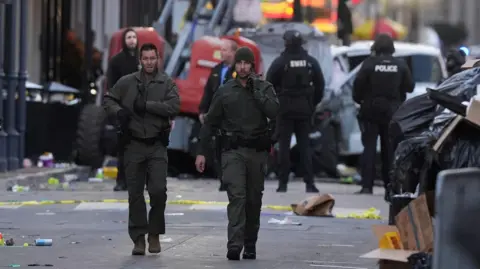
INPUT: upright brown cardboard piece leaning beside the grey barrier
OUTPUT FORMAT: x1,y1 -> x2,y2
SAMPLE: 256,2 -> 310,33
395,194 -> 433,252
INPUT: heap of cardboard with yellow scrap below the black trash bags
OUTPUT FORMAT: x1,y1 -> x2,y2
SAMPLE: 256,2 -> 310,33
360,194 -> 434,269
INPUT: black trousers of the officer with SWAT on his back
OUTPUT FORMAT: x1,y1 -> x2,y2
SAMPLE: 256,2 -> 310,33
277,118 -> 314,184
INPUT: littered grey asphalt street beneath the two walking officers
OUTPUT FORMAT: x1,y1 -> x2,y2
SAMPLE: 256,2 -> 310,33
0,180 -> 387,269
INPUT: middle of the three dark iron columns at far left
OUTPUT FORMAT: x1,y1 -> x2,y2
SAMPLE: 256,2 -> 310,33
4,1 -> 20,170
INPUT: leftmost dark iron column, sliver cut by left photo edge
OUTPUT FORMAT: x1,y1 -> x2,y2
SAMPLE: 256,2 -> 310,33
0,4 -> 7,173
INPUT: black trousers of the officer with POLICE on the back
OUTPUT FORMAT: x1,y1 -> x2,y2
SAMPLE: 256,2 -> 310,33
358,120 -> 393,189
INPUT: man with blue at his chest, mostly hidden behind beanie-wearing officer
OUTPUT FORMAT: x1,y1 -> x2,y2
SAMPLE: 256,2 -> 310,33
199,40 -> 237,191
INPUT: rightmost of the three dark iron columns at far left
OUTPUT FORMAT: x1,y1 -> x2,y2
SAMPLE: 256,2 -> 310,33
17,0 -> 28,166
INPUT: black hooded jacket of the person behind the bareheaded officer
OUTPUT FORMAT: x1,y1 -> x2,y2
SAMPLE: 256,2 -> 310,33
107,29 -> 140,89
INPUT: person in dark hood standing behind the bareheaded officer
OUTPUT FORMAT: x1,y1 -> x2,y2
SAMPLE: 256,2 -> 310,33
107,28 -> 140,191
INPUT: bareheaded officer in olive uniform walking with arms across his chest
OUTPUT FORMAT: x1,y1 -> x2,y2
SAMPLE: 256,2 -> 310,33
103,43 -> 180,255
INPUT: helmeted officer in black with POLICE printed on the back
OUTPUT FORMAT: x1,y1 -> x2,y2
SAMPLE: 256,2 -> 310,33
352,34 -> 415,197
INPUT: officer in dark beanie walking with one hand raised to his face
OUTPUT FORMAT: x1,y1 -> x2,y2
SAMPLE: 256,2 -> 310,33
195,47 -> 279,260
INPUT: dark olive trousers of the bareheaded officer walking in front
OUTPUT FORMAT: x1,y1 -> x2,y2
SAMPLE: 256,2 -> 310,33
125,140 -> 168,241
